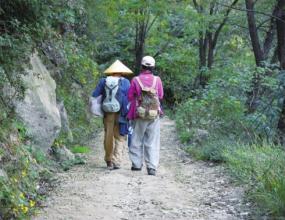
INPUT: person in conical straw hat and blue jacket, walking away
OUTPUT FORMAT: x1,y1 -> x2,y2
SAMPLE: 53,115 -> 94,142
92,60 -> 133,170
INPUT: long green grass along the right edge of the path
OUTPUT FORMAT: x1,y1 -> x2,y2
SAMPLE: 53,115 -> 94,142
183,132 -> 285,219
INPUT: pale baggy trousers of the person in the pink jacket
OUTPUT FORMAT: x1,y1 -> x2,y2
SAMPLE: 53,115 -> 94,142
129,118 -> 160,169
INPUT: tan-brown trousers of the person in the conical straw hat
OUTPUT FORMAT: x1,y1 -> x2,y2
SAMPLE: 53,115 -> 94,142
103,113 -> 126,165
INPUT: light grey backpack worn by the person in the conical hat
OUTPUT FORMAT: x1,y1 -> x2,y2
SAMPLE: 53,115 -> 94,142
102,76 -> 121,112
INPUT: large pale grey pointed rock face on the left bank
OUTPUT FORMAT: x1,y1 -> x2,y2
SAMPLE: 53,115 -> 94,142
16,54 -> 61,149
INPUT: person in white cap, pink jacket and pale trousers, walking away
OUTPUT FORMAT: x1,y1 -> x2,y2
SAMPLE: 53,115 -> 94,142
127,56 -> 163,175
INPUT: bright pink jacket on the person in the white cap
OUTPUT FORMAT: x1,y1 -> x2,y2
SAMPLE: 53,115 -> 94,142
127,70 -> 163,120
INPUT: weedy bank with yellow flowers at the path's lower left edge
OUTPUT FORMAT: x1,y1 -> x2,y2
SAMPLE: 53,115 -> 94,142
0,127 -> 55,219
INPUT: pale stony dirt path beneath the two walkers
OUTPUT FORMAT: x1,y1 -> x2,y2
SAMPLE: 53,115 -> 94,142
34,118 -> 249,220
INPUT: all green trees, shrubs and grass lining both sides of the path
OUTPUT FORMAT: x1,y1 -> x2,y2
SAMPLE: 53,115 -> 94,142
0,0 -> 285,219
